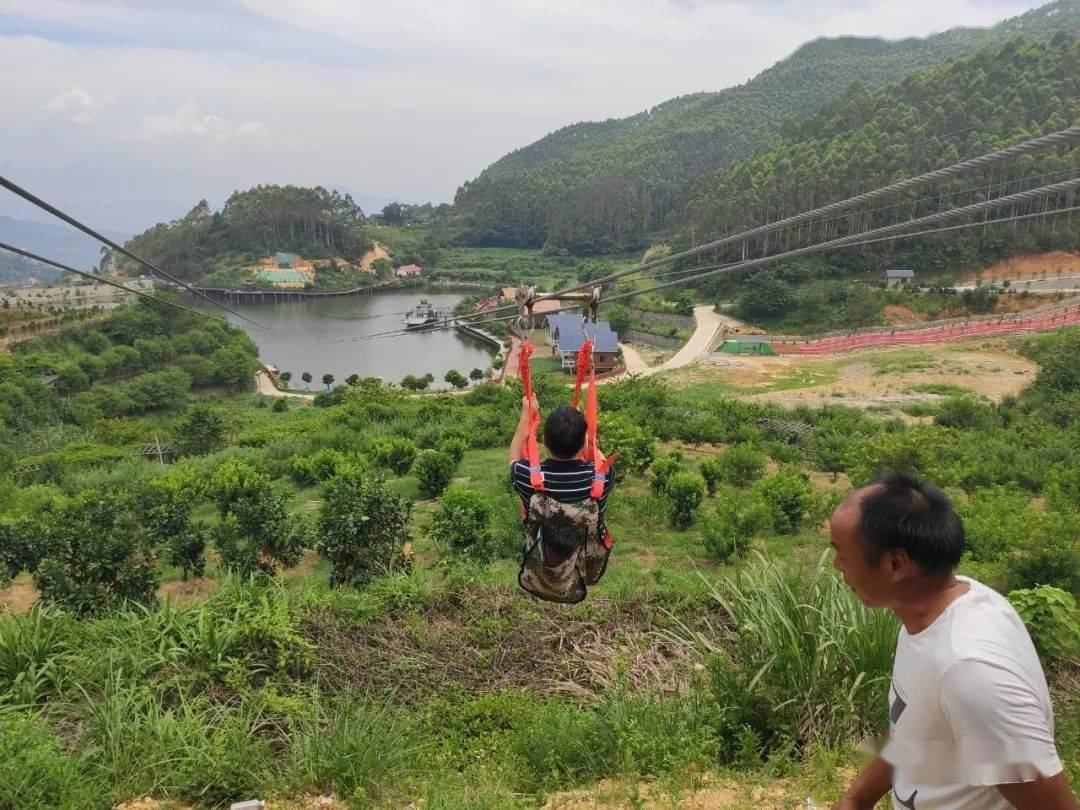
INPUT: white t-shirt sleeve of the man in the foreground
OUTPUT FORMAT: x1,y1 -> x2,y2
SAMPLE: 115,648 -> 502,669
941,660 -> 1062,785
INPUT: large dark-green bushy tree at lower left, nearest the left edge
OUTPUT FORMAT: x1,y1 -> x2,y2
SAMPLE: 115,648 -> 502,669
33,490 -> 160,615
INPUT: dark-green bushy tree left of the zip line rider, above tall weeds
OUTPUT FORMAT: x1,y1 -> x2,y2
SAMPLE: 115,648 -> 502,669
315,467 -> 409,585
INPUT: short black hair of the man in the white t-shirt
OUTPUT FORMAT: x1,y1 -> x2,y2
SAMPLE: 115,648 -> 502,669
859,472 -> 963,575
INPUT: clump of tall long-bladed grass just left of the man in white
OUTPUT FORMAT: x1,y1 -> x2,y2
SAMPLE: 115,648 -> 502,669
698,553 -> 899,745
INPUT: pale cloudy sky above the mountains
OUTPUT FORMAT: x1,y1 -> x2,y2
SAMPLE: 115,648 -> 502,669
0,0 -> 1040,232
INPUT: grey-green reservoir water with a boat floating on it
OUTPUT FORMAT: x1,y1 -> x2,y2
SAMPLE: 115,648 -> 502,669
208,289 -> 496,390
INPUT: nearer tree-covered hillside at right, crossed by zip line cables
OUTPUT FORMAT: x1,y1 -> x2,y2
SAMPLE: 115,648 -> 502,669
675,37 -> 1080,289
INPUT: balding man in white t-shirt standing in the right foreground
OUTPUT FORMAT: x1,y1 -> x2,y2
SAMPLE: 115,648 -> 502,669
829,473 -> 1077,810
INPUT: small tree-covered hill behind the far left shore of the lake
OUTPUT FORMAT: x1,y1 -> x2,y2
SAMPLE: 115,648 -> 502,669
121,186 -> 367,279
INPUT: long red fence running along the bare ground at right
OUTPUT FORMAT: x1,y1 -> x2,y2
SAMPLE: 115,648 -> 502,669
769,306 -> 1080,354
